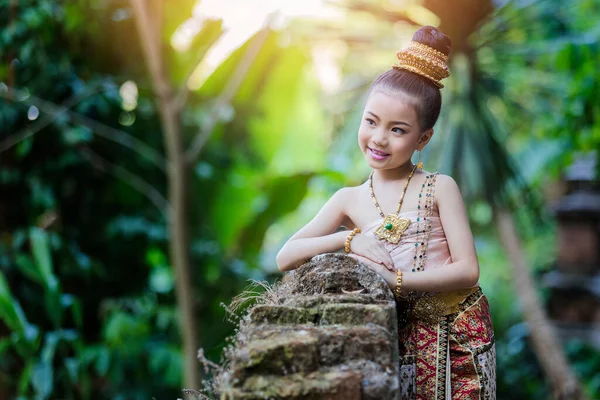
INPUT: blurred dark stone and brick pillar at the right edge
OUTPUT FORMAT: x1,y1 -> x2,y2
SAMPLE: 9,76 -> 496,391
543,153 -> 600,348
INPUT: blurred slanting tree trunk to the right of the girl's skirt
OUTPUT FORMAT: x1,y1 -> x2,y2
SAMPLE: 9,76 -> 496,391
496,208 -> 585,400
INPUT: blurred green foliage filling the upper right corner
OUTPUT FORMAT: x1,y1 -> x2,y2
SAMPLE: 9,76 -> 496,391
474,0 -> 600,178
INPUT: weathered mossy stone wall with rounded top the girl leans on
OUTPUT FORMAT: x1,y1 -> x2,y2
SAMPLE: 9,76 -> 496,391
221,254 -> 399,400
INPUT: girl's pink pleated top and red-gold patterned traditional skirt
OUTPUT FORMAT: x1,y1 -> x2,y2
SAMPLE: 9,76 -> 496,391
362,173 -> 496,400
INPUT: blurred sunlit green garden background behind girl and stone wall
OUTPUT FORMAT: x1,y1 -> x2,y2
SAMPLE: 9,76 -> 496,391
0,0 -> 600,400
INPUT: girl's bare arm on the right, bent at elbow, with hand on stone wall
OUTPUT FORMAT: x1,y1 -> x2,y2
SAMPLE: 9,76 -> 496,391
355,175 -> 479,292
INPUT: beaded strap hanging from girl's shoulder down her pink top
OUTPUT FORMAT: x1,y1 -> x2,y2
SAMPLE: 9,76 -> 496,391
412,172 -> 438,272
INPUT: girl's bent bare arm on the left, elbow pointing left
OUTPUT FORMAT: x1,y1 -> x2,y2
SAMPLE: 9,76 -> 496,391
277,188 -> 349,271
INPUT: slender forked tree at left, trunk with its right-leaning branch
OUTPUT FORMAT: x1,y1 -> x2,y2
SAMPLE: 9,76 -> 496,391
130,0 -> 267,388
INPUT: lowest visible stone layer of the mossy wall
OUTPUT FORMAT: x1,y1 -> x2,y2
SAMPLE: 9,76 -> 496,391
221,370 -> 361,400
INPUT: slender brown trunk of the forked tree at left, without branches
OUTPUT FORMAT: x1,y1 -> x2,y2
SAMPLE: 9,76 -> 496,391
131,0 -> 200,388
